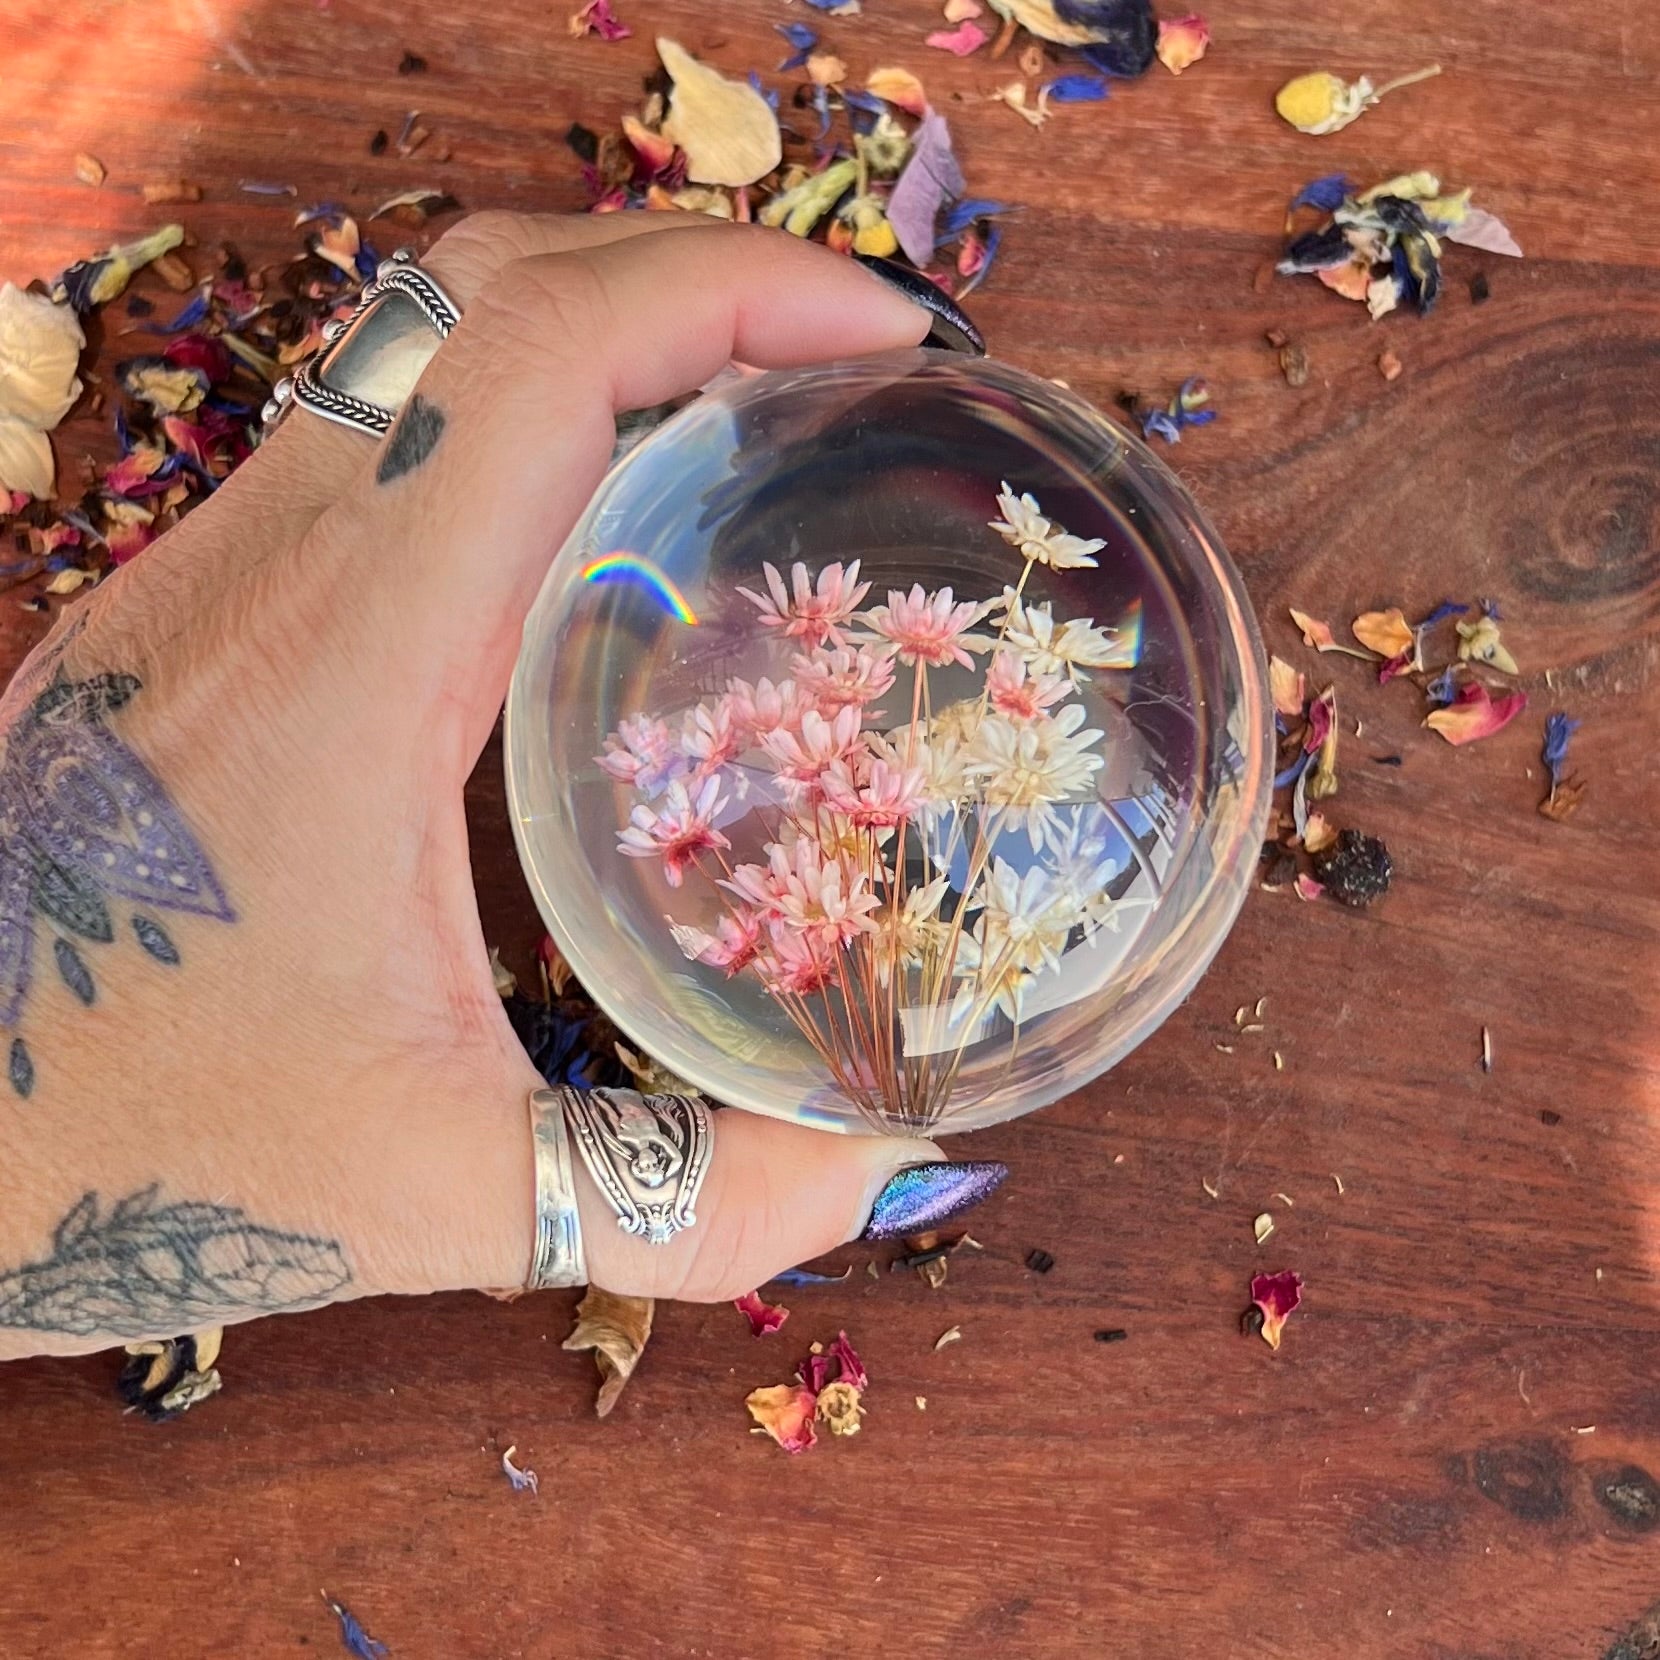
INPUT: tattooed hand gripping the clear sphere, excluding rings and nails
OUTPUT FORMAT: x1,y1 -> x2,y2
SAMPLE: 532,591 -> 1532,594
0,214 -> 962,1358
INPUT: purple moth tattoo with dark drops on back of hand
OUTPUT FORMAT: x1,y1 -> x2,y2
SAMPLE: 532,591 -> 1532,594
0,666 -> 236,1097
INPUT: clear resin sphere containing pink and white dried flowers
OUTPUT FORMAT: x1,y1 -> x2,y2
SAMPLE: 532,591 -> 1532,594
506,352 -> 1273,1134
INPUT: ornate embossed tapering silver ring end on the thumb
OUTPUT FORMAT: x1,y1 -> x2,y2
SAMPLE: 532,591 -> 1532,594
561,1089 -> 714,1245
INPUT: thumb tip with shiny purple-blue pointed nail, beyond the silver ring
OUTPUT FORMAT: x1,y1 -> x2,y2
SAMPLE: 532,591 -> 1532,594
578,1111 -> 1009,1303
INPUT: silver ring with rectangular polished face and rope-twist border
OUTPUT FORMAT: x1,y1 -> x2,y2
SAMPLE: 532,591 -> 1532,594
264,247 -> 461,438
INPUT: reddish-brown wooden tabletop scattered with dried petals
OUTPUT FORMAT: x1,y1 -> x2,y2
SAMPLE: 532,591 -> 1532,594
0,0 -> 1660,1660
